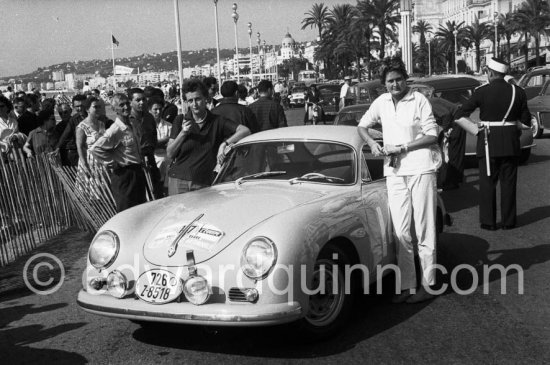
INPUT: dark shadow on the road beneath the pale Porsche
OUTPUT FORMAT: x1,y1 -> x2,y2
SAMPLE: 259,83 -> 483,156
133,275 -> 430,359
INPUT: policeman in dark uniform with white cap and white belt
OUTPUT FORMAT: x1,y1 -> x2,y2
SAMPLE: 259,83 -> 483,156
457,58 -> 531,231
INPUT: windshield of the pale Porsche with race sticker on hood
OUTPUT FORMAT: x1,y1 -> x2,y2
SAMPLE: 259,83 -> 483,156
216,141 -> 356,185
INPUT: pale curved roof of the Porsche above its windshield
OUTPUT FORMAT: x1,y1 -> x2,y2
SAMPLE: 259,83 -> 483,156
239,125 -> 363,146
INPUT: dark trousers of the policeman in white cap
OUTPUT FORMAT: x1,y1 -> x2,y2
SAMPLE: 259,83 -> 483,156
479,156 -> 519,228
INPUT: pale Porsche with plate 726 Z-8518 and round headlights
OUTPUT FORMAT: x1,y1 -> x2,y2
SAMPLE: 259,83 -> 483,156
78,126 -> 448,337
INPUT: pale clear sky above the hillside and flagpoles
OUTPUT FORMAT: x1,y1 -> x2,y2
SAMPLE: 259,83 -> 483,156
0,0 -> 356,77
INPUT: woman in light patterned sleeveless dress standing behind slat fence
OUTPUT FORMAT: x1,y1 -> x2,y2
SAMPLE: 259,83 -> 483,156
76,97 -> 105,180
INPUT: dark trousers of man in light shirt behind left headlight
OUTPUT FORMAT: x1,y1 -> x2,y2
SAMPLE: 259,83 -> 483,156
111,164 -> 146,212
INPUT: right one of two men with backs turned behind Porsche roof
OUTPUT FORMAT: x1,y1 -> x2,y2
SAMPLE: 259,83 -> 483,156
250,80 -> 287,131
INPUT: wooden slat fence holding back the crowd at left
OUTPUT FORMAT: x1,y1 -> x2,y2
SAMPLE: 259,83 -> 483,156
0,147 -> 154,267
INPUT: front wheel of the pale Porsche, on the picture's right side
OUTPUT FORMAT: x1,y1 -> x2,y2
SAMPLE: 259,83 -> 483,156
298,244 -> 353,340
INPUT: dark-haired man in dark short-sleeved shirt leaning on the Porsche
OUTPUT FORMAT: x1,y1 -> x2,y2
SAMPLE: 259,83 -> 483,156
166,80 -> 250,195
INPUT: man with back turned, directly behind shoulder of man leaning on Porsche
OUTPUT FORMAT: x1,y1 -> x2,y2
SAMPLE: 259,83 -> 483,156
212,81 -> 260,133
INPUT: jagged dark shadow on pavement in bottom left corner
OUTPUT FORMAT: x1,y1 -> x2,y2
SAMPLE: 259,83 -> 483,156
0,303 -> 88,364
